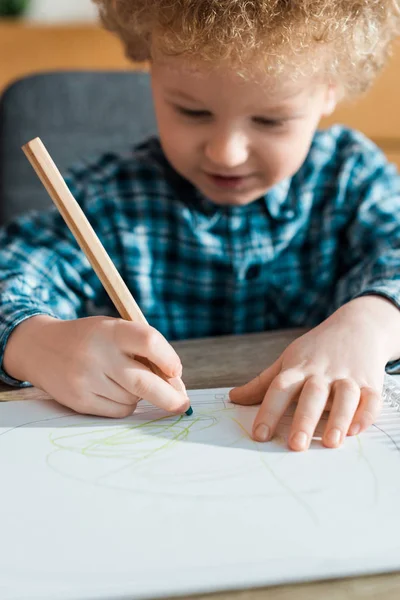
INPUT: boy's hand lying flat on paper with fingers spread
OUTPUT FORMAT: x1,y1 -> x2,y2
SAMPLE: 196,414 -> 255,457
230,296 -> 400,450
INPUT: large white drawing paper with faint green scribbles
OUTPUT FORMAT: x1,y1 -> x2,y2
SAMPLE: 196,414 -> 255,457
0,389 -> 400,600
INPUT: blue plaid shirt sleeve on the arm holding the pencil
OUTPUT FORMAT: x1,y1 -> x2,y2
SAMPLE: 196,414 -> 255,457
0,170 -> 111,387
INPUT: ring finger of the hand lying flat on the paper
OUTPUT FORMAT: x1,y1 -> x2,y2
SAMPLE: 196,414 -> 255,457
322,379 -> 360,448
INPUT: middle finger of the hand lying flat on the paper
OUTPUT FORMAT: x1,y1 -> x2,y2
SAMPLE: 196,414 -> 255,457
289,376 -> 330,451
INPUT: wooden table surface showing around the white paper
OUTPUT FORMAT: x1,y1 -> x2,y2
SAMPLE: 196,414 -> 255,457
0,330 -> 400,600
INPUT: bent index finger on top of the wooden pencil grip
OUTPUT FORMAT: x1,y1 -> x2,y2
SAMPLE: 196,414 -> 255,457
116,319 -> 182,377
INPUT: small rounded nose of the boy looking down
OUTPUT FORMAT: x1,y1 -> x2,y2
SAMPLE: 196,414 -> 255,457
205,132 -> 249,169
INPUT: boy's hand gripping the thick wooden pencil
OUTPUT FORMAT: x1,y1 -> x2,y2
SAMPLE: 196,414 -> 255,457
3,315 -> 189,417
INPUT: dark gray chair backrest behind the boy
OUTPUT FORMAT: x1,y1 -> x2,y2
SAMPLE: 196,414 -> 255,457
0,71 -> 157,225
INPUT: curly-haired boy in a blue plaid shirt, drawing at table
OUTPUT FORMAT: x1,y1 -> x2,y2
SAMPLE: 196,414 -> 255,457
0,0 -> 400,450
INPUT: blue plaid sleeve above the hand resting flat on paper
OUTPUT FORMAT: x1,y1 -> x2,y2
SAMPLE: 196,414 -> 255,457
333,143 -> 400,373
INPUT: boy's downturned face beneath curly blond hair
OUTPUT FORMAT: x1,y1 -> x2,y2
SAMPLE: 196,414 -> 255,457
152,56 -> 335,205
